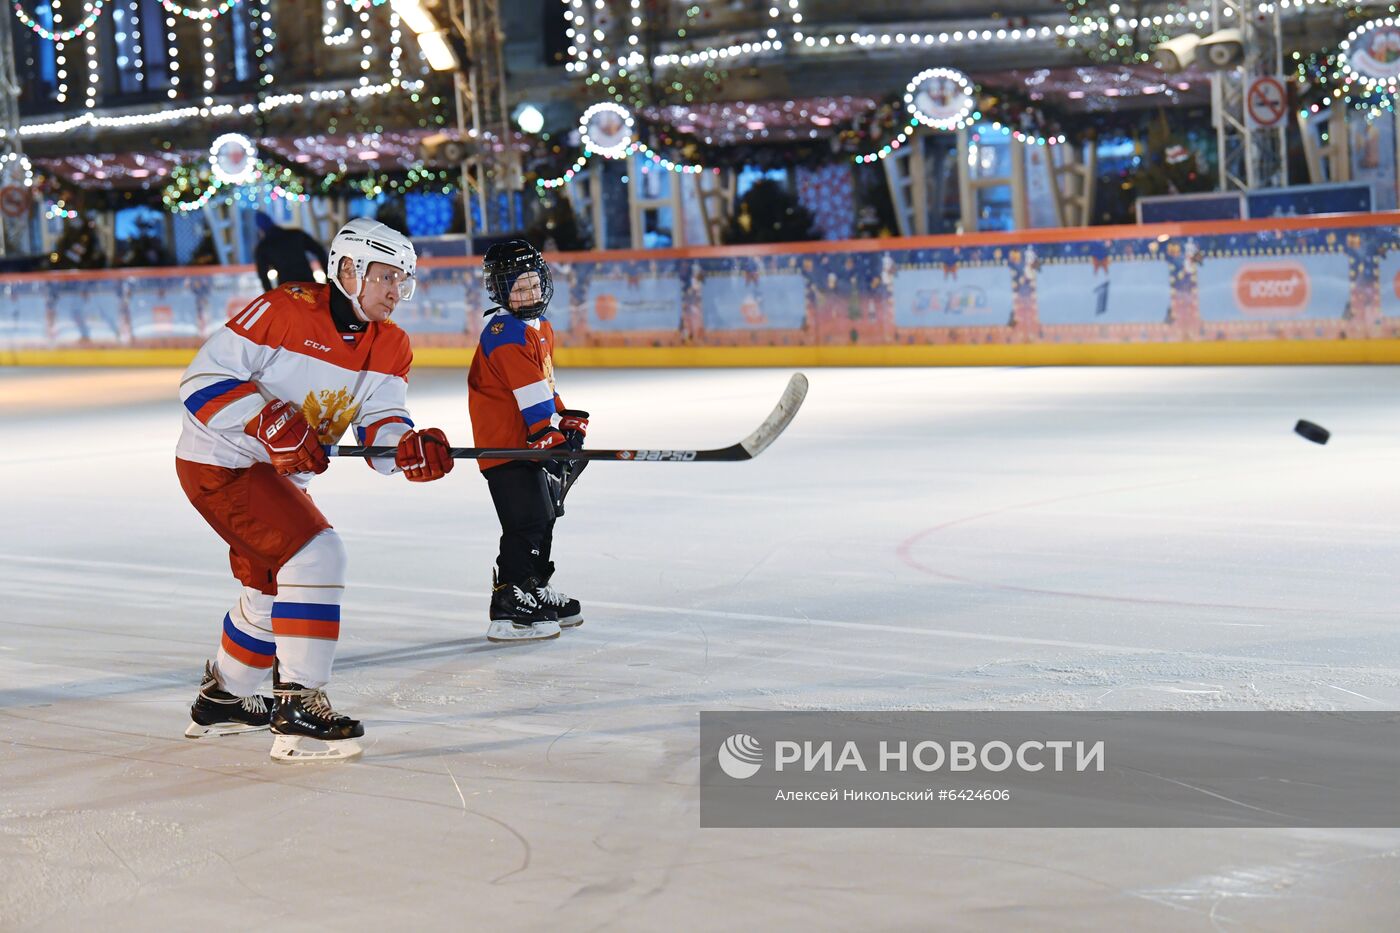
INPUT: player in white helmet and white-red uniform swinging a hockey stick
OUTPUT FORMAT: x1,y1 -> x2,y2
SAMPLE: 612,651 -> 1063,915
175,217 -> 452,761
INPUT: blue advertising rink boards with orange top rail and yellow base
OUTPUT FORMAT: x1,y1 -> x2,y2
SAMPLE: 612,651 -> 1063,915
8,213 -> 1400,367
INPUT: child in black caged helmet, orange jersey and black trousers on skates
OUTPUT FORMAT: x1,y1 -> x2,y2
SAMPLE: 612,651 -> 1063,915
468,240 -> 588,642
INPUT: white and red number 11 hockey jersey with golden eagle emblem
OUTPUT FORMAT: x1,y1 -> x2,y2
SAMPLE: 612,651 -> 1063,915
175,283 -> 413,478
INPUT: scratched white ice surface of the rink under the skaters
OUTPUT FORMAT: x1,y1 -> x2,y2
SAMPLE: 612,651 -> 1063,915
0,367 -> 1400,933
